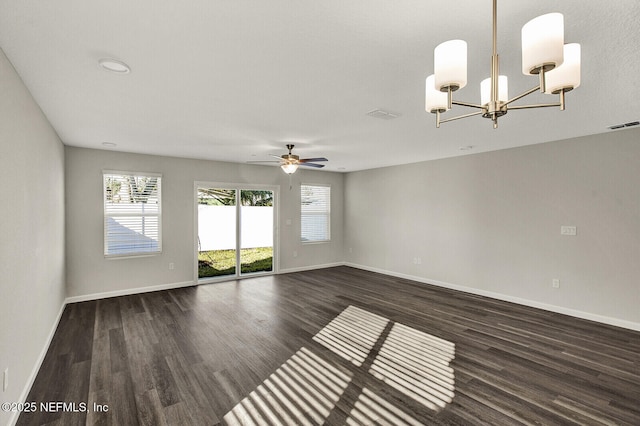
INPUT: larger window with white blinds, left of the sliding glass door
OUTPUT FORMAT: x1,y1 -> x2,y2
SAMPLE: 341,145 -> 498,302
103,172 -> 162,256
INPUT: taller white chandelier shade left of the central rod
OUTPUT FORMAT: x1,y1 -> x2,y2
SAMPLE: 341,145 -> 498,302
433,40 -> 467,92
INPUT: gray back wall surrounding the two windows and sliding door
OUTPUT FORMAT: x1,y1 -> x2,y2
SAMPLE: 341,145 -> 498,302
65,147 -> 344,297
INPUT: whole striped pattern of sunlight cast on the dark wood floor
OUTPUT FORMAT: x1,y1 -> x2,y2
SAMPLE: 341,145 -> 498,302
224,306 -> 455,426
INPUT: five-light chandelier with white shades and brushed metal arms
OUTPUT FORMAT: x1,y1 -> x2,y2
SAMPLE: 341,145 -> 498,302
425,0 -> 580,129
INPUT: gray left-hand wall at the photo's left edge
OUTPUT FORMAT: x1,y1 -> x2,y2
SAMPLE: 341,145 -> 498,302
0,50 -> 65,425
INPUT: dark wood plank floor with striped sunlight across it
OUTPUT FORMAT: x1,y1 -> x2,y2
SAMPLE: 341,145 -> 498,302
18,267 -> 640,426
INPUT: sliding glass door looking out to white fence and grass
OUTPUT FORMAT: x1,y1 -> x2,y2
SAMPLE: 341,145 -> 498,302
196,183 -> 277,282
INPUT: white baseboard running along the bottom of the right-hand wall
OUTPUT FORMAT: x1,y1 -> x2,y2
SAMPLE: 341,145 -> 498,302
344,262 -> 640,331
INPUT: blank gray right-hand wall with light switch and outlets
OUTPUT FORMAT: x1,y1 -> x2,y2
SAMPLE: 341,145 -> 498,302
345,129 -> 640,329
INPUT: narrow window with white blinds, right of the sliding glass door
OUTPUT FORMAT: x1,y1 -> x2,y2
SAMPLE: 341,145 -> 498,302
300,185 -> 331,242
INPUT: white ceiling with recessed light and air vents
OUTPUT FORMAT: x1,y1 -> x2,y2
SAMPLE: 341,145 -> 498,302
0,0 -> 640,171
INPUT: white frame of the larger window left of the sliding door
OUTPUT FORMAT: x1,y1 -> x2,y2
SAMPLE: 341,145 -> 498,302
102,170 -> 162,259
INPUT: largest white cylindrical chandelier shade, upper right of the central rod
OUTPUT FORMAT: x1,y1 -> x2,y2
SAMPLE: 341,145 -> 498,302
522,13 -> 564,75
